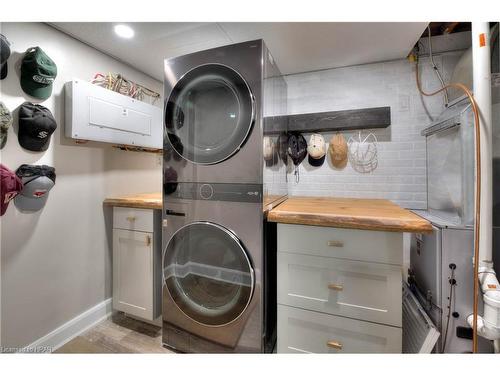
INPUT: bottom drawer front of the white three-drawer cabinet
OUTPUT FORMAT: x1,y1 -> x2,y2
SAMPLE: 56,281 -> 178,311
277,305 -> 402,353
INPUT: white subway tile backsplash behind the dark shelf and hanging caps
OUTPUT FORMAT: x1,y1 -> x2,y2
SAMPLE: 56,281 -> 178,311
276,52 -> 462,209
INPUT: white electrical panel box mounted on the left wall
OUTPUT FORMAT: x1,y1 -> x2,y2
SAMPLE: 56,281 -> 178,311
65,79 -> 163,149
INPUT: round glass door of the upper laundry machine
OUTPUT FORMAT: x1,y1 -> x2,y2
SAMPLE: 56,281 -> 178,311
165,64 -> 254,164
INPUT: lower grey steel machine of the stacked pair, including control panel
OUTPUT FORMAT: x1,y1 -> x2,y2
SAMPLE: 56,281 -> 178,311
162,183 -> 276,353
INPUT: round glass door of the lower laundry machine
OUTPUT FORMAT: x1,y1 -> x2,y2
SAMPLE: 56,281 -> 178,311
163,222 -> 254,326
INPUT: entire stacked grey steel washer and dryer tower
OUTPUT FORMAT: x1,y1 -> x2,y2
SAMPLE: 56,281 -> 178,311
162,40 -> 287,353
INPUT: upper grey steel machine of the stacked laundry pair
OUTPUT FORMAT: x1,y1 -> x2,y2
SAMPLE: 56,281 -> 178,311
164,40 -> 286,184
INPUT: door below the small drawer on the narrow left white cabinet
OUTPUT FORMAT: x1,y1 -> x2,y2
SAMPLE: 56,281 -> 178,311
113,229 -> 155,320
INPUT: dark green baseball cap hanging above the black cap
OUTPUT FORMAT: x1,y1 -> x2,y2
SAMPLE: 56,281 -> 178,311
21,47 -> 57,100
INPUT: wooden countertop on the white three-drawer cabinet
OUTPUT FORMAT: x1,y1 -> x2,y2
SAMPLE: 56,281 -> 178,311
267,197 -> 432,233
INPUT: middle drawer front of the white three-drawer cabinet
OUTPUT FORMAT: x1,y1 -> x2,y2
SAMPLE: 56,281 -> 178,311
278,253 -> 402,327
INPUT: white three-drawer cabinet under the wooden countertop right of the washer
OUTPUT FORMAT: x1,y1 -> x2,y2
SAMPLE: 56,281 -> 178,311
277,224 -> 403,353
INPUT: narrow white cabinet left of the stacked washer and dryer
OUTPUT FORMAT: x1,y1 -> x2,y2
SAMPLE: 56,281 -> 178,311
113,207 -> 161,320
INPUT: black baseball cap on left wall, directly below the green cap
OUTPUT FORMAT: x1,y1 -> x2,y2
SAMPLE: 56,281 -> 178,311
18,102 -> 57,151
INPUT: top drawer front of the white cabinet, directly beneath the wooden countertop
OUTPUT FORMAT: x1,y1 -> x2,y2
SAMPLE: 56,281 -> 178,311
278,224 -> 403,265
